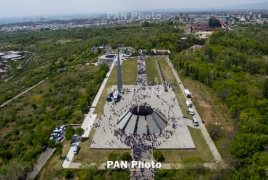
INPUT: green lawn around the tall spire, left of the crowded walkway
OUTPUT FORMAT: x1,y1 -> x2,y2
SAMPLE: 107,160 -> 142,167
94,58 -> 137,117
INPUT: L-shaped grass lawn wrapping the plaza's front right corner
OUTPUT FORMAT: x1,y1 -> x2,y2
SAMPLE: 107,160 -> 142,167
161,127 -> 212,163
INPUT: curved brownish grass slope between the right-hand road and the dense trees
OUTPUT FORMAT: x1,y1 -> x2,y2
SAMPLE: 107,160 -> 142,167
180,76 -> 233,159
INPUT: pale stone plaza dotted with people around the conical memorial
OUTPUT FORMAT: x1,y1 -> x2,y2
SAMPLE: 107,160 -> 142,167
90,85 -> 195,149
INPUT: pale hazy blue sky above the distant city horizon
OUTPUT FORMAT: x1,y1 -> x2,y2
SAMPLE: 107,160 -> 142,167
0,0 -> 267,18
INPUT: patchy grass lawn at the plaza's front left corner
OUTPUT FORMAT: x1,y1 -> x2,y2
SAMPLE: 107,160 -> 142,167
73,128 -> 131,163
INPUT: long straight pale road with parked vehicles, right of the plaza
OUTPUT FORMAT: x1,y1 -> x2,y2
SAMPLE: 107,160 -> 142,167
166,56 -> 223,162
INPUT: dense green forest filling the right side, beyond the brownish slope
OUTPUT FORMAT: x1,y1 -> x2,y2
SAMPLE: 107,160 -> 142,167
168,26 -> 268,179
